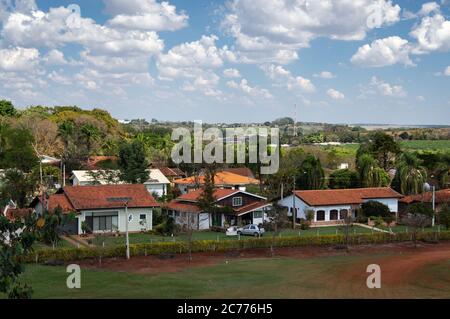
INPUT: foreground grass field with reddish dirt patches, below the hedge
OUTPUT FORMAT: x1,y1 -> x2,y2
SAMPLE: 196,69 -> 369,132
10,253 -> 450,298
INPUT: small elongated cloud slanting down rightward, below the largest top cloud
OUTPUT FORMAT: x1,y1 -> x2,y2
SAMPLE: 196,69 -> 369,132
261,64 -> 316,93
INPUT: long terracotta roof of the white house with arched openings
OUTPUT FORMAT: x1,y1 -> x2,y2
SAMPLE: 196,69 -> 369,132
295,187 -> 403,206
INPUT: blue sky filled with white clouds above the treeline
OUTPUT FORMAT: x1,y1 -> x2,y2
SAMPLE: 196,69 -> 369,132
0,0 -> 450,125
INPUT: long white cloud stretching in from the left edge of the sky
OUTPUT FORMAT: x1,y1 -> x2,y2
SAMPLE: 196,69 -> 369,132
1,7 -> 164,55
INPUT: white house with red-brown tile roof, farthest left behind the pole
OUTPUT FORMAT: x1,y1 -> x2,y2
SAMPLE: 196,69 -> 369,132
31,184 -> 159,234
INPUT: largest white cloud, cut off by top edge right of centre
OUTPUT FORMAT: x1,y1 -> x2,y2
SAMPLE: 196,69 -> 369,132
222,0 -> 401,64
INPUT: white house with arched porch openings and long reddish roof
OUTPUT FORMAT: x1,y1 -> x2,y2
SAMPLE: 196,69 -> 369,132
278,187 -> 403,225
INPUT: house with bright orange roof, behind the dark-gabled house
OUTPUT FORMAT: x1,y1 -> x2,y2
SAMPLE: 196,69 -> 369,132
173,171 -> 259,194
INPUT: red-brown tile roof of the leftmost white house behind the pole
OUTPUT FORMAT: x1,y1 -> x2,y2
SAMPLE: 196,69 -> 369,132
63,184 -> 159,210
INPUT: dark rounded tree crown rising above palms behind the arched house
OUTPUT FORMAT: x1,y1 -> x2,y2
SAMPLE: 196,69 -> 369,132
368,132 -> 400,170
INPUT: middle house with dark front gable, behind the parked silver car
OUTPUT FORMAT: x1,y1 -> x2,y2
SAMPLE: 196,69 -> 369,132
164,188 -> 271,230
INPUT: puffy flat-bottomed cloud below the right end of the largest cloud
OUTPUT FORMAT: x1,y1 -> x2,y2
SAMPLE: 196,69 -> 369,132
350,36 -> 414,67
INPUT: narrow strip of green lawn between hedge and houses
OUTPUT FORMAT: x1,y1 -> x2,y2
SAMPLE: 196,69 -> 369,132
93,226 -> 372,246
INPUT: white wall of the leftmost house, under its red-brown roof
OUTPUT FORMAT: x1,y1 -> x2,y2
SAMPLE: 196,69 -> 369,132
77,208 -> 153,234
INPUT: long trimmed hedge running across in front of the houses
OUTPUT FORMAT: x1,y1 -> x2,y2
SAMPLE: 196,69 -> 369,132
23,231 -> 450,262
